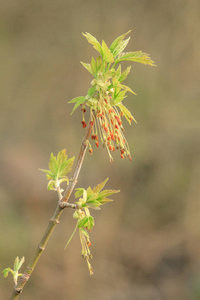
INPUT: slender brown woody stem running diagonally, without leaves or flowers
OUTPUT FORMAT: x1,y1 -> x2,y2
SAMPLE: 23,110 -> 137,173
10,124 -> 92,300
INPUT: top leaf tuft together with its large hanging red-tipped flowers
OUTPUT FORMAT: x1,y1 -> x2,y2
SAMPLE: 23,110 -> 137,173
69,31 -> 155,162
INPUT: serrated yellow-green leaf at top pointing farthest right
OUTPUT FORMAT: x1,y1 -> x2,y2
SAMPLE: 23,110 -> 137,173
115,51 -> 156,66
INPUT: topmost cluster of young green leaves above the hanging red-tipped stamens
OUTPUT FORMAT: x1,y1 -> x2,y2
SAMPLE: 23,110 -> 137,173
69,31 -> 155,118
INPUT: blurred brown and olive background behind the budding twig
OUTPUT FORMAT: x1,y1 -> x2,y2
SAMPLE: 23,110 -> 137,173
0,0 -> 200,300
